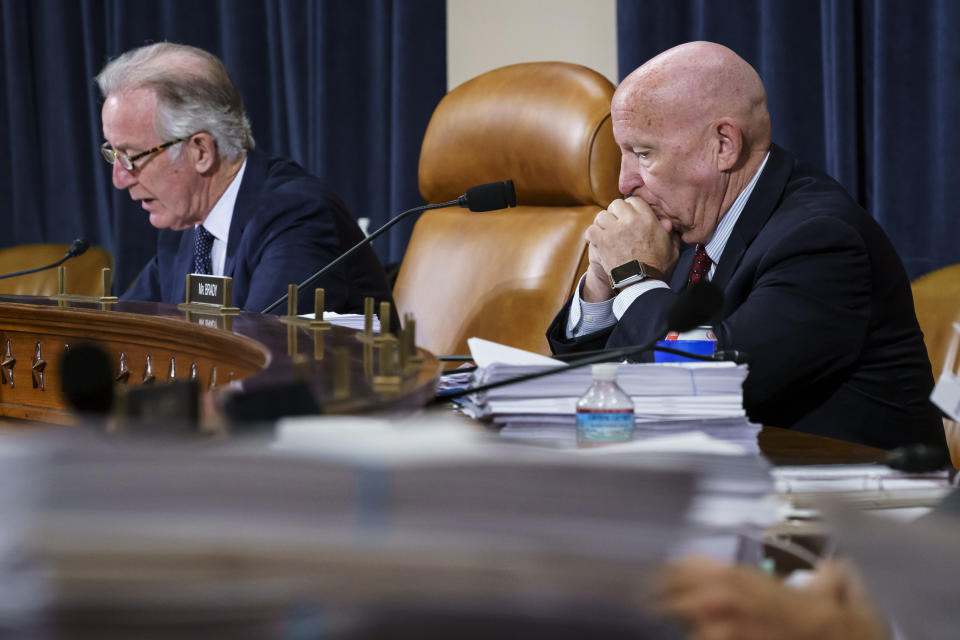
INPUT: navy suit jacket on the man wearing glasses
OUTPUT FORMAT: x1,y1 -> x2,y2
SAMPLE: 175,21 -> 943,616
122,150 -> 396,326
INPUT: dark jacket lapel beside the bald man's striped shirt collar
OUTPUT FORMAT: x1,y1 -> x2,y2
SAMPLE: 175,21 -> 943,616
708,144 -> 793,288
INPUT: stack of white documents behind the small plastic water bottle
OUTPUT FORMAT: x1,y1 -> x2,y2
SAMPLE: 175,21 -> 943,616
463,339 -> 760,452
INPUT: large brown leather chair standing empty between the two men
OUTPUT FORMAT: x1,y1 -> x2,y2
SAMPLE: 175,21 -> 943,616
393,62 -> 620,355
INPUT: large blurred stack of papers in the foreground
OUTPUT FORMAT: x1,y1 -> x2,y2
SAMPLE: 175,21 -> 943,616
0,424 -> 696,637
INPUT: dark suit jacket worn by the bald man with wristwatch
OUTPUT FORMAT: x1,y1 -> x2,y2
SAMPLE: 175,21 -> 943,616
547,145 -> 946,449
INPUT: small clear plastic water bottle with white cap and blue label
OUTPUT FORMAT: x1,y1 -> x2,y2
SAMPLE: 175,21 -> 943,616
577,364 -> 633,447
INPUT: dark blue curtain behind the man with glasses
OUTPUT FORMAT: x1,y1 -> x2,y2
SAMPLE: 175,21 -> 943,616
0,0 -> 446,288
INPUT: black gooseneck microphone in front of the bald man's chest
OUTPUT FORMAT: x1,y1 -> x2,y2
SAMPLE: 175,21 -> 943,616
432,280 -> 723,402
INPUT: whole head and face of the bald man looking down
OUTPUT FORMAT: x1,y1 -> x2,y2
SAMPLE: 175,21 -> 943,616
610,42 -> 770,244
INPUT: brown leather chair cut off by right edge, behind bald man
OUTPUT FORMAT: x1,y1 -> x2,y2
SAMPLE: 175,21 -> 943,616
910,264 -> 960,468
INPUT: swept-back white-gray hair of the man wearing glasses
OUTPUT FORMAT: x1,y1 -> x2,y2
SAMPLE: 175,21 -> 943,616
96,42 -> 254,162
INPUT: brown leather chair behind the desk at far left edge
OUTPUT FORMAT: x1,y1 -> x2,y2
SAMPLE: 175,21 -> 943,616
0,244 -> 113,296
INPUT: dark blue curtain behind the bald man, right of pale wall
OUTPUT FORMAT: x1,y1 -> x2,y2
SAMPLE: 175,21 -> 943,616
617,0 -> 960,278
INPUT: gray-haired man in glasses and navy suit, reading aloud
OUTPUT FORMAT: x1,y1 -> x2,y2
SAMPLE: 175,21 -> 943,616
96,42 -> 391,313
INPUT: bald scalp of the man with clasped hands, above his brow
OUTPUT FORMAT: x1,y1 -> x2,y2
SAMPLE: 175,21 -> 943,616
612,42 -> 770,153
